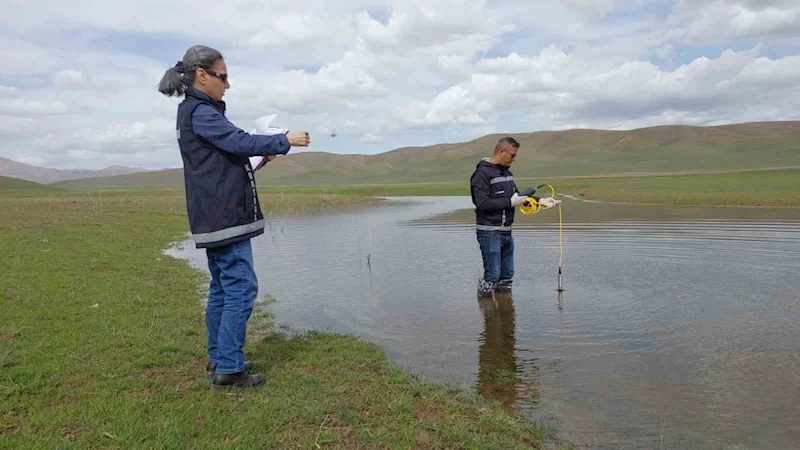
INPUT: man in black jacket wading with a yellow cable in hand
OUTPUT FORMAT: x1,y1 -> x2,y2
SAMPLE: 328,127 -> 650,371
470,137 -> 560,297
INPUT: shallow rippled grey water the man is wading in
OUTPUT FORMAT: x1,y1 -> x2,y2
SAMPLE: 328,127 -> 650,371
171,197 -> 800,449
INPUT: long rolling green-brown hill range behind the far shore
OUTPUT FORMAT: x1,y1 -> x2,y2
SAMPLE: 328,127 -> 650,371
53,121 -> 800,189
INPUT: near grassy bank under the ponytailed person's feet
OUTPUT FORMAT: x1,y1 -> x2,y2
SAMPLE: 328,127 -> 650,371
0,191 -> 562,449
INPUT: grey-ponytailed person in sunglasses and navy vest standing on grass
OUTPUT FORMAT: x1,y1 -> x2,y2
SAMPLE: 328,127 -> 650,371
158,45 -> 310,390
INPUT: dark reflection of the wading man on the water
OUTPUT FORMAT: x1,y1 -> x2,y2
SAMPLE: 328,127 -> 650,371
478,293 -> 518,409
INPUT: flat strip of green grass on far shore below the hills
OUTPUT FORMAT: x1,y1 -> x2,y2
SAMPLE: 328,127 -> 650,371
260,168 -> 800,206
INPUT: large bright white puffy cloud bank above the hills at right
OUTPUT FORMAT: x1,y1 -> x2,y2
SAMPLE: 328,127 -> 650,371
382,47 -> 800,132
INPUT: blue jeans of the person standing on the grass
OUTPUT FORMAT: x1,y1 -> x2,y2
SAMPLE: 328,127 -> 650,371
206,239 -> 258,373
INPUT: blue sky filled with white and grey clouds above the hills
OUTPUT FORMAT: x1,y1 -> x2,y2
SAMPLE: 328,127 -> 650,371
0,0 -> 800,169
